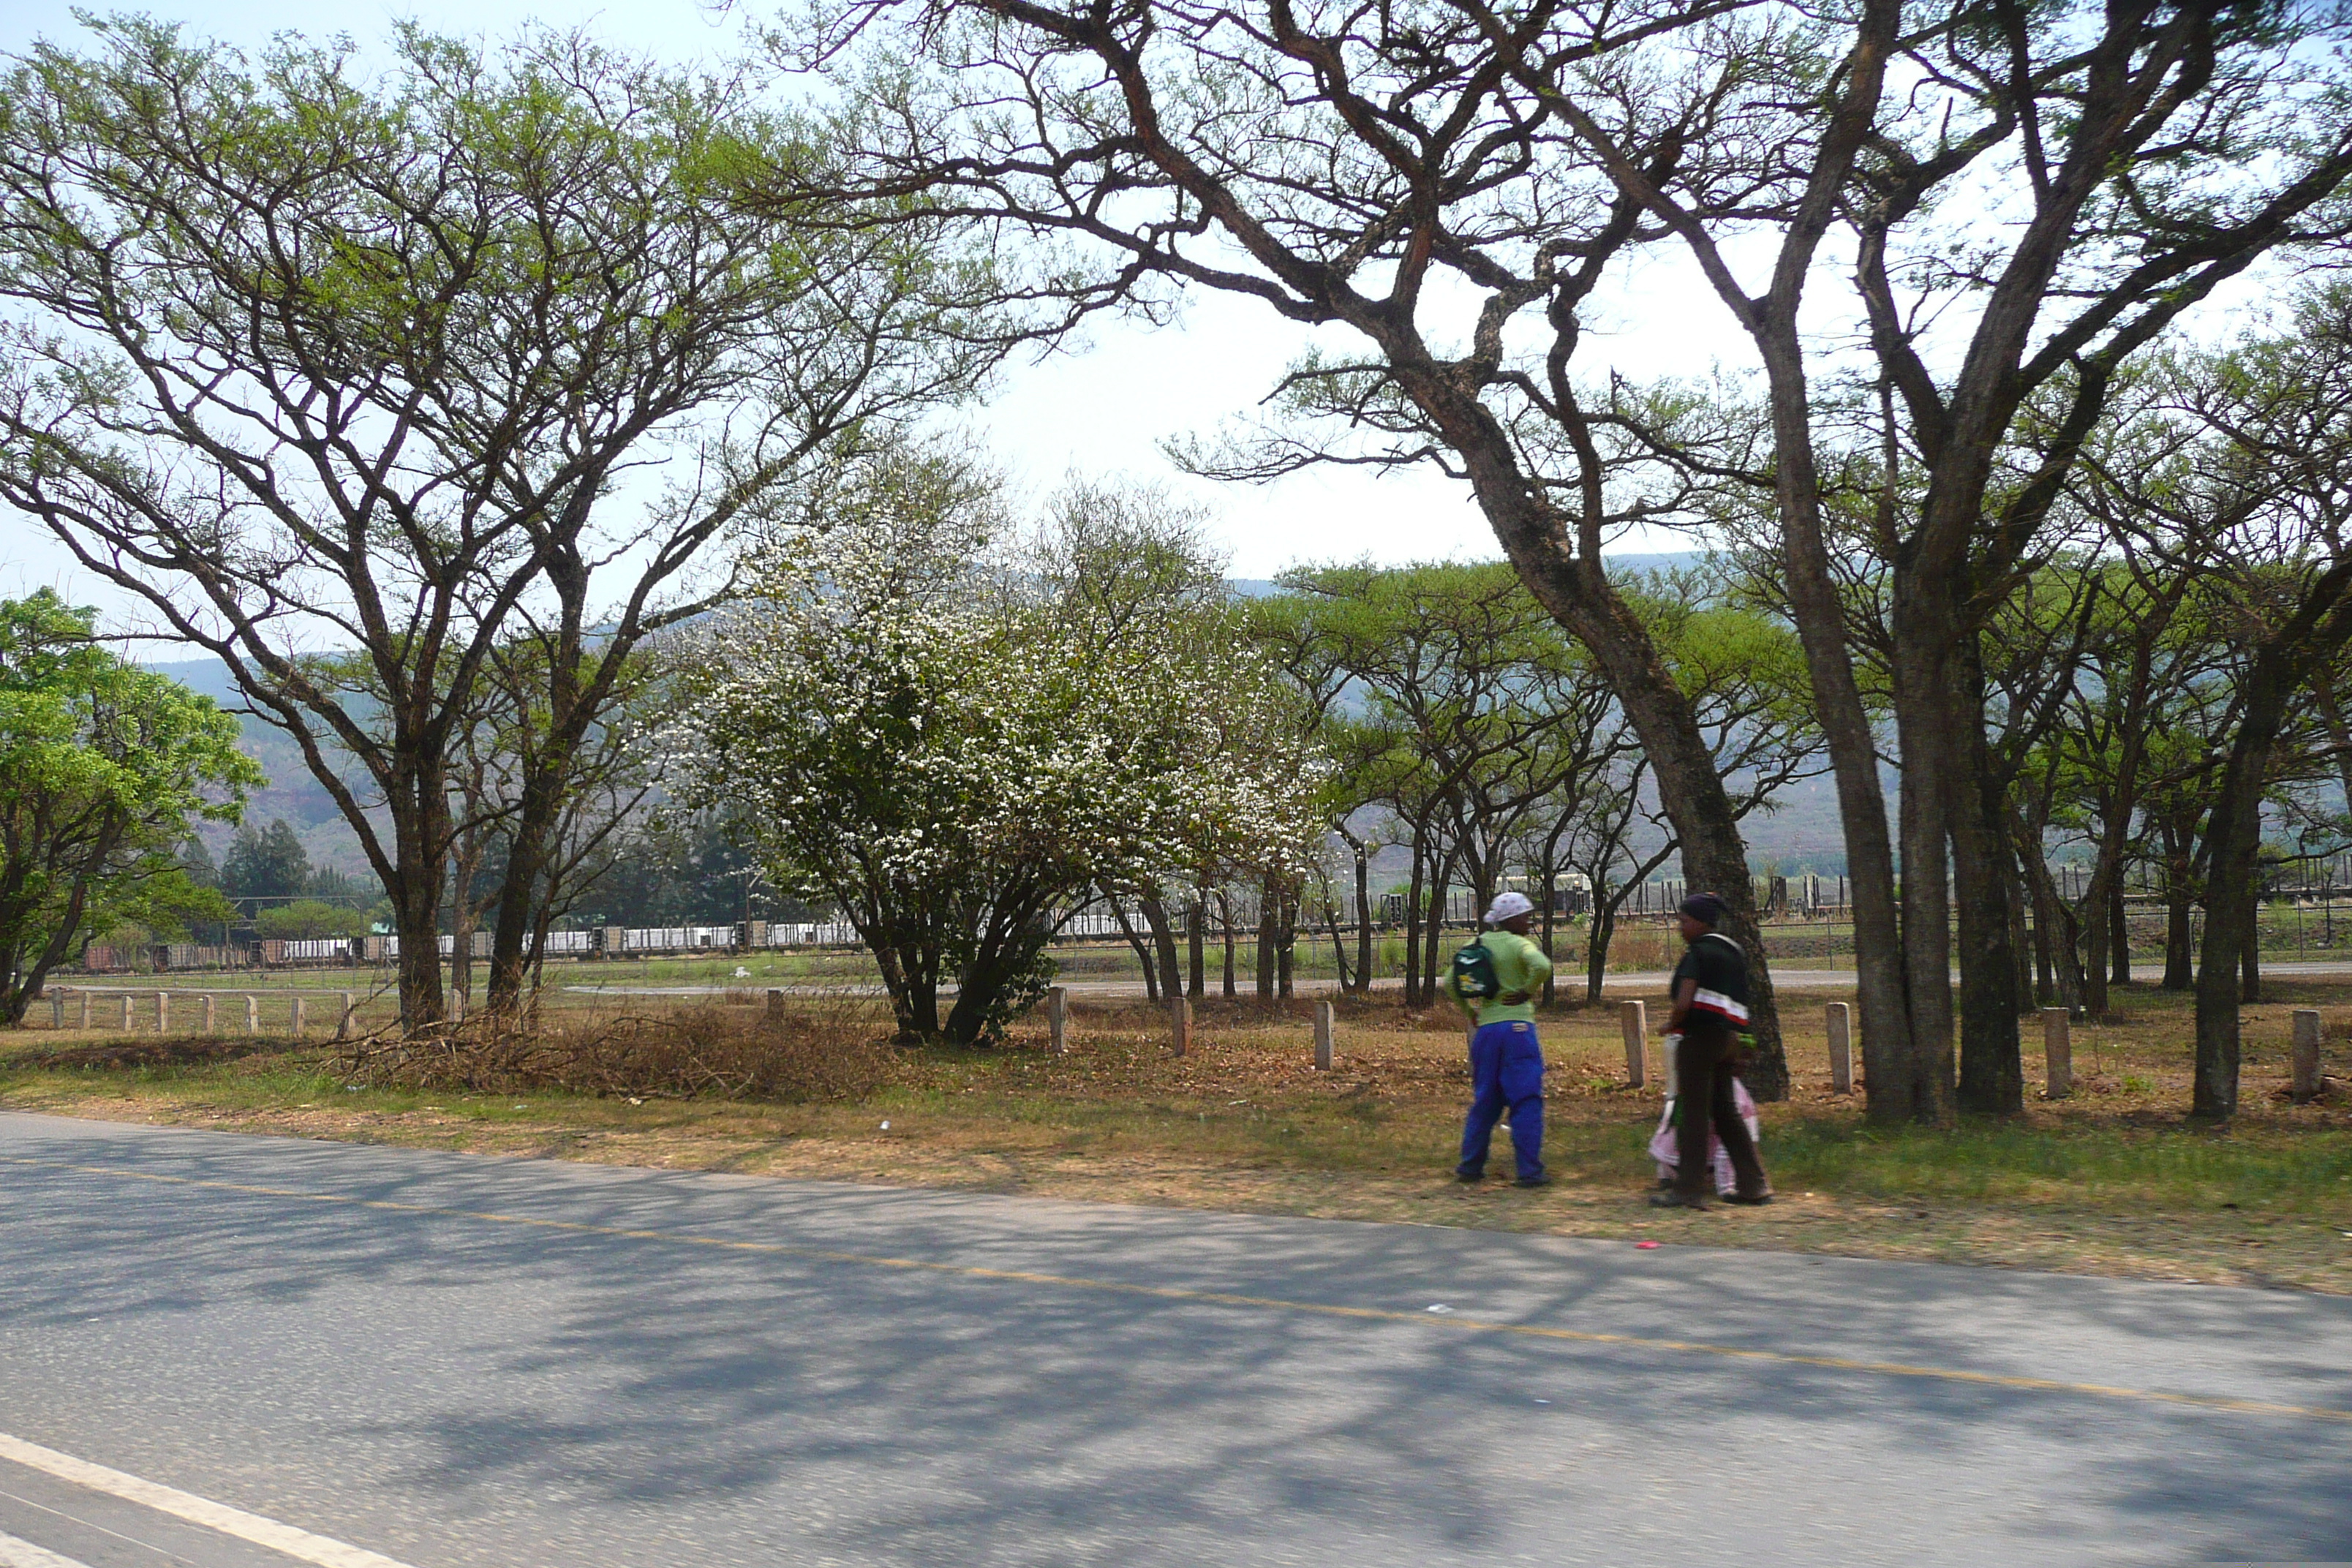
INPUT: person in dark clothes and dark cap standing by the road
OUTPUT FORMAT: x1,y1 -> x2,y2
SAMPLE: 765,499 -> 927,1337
1648,893 -> 1771,1208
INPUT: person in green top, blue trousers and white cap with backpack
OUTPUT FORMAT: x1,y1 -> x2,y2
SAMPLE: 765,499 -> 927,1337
1447,893 -> 1553,1187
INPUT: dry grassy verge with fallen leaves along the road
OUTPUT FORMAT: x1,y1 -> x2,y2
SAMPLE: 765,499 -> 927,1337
0,983 -> 2352,1293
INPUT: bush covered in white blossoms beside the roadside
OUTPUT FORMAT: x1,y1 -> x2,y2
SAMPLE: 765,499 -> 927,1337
685,453 -> 1322,1041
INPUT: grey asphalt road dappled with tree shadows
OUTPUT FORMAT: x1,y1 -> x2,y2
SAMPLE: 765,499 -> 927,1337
0,1115 -> 2352,1568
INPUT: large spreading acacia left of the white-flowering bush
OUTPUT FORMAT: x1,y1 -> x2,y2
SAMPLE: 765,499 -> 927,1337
0,19 -> 992,1028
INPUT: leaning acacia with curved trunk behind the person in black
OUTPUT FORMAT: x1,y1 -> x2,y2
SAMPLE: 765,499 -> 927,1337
776,0 -> 1778,1081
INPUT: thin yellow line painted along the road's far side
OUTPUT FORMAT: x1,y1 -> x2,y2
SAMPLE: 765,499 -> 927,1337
0,1154 -> 2352,1422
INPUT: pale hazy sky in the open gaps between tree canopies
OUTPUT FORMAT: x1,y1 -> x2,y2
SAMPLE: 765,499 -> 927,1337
0,0 -> 1768,625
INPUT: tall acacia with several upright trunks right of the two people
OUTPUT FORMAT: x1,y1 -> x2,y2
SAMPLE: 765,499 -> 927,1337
1477,0 -> 2352,1121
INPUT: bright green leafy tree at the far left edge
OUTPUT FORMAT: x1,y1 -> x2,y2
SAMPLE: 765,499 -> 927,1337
0,588 -> 265,1025
